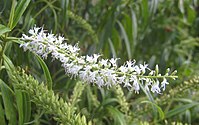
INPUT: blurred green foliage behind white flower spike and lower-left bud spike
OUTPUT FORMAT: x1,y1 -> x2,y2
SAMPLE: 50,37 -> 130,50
0,0 -> 199,125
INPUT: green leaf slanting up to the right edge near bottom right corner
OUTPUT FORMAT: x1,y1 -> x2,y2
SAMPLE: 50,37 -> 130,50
165,102 -> 199,118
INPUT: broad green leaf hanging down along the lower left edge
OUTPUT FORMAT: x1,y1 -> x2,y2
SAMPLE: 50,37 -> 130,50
0,79 -> 17,125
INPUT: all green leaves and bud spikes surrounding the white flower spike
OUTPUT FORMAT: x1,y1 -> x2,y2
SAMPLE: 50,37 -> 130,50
0,0 -> 199,125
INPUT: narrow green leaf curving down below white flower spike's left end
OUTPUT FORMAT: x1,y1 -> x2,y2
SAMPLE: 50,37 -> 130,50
36,55 -> 52,90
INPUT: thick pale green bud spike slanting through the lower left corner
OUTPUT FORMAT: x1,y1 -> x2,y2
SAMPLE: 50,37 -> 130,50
12,69 -> 87,125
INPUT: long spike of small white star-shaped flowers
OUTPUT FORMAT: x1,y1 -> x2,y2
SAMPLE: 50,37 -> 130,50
20,27 -> 177,93
